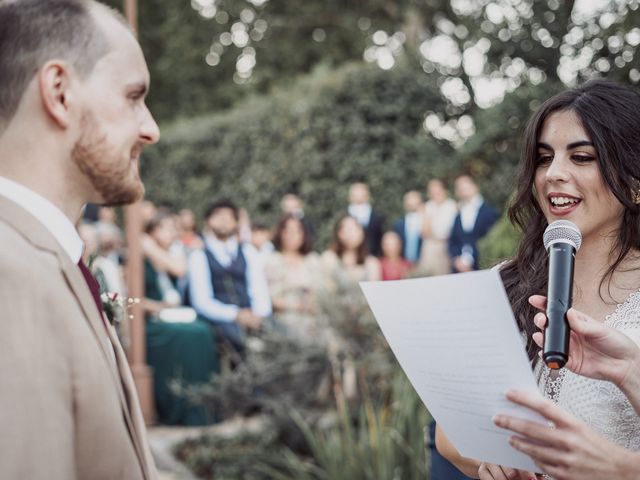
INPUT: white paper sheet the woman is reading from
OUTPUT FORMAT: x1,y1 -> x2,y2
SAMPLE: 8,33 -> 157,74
360,270 -> 546,472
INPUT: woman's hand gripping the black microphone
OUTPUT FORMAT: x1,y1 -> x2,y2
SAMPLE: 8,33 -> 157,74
529,295 -> 640,388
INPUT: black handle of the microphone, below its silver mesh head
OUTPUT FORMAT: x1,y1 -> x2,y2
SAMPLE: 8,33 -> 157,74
542,242 -> 576,369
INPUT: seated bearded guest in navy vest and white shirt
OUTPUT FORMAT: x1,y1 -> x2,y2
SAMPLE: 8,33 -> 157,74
189,200 -> 271,352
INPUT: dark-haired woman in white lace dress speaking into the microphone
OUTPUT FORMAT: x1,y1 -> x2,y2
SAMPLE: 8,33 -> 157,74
437,80 -> 640,479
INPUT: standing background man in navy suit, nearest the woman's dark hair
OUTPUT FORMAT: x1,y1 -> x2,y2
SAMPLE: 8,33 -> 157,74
449,175 -> 498,272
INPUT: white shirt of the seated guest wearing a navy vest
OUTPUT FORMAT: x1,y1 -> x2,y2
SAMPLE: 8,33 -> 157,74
188,235 -> 271,322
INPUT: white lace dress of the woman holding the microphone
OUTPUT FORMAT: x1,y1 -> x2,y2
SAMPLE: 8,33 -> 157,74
536,291 -> 640,462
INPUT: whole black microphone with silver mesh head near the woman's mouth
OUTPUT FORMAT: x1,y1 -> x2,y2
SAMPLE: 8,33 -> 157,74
542,220 -> 582,370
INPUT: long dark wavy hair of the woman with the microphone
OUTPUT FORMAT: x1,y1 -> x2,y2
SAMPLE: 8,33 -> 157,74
500,80 -> 640,362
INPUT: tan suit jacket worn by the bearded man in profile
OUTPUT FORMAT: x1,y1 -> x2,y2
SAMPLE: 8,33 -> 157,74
0,196 -> 157,480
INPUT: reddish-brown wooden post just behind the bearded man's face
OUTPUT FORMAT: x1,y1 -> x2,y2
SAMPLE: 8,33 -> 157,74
124,0 -> 155,425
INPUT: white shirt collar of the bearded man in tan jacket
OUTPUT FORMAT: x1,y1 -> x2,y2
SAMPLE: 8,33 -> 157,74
0,177 -> 84,263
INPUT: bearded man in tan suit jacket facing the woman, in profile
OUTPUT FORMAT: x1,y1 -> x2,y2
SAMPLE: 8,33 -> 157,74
0,0 -> 159,480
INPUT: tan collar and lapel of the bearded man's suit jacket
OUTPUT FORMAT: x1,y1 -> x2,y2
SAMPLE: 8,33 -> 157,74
0,196 -> 149,478
